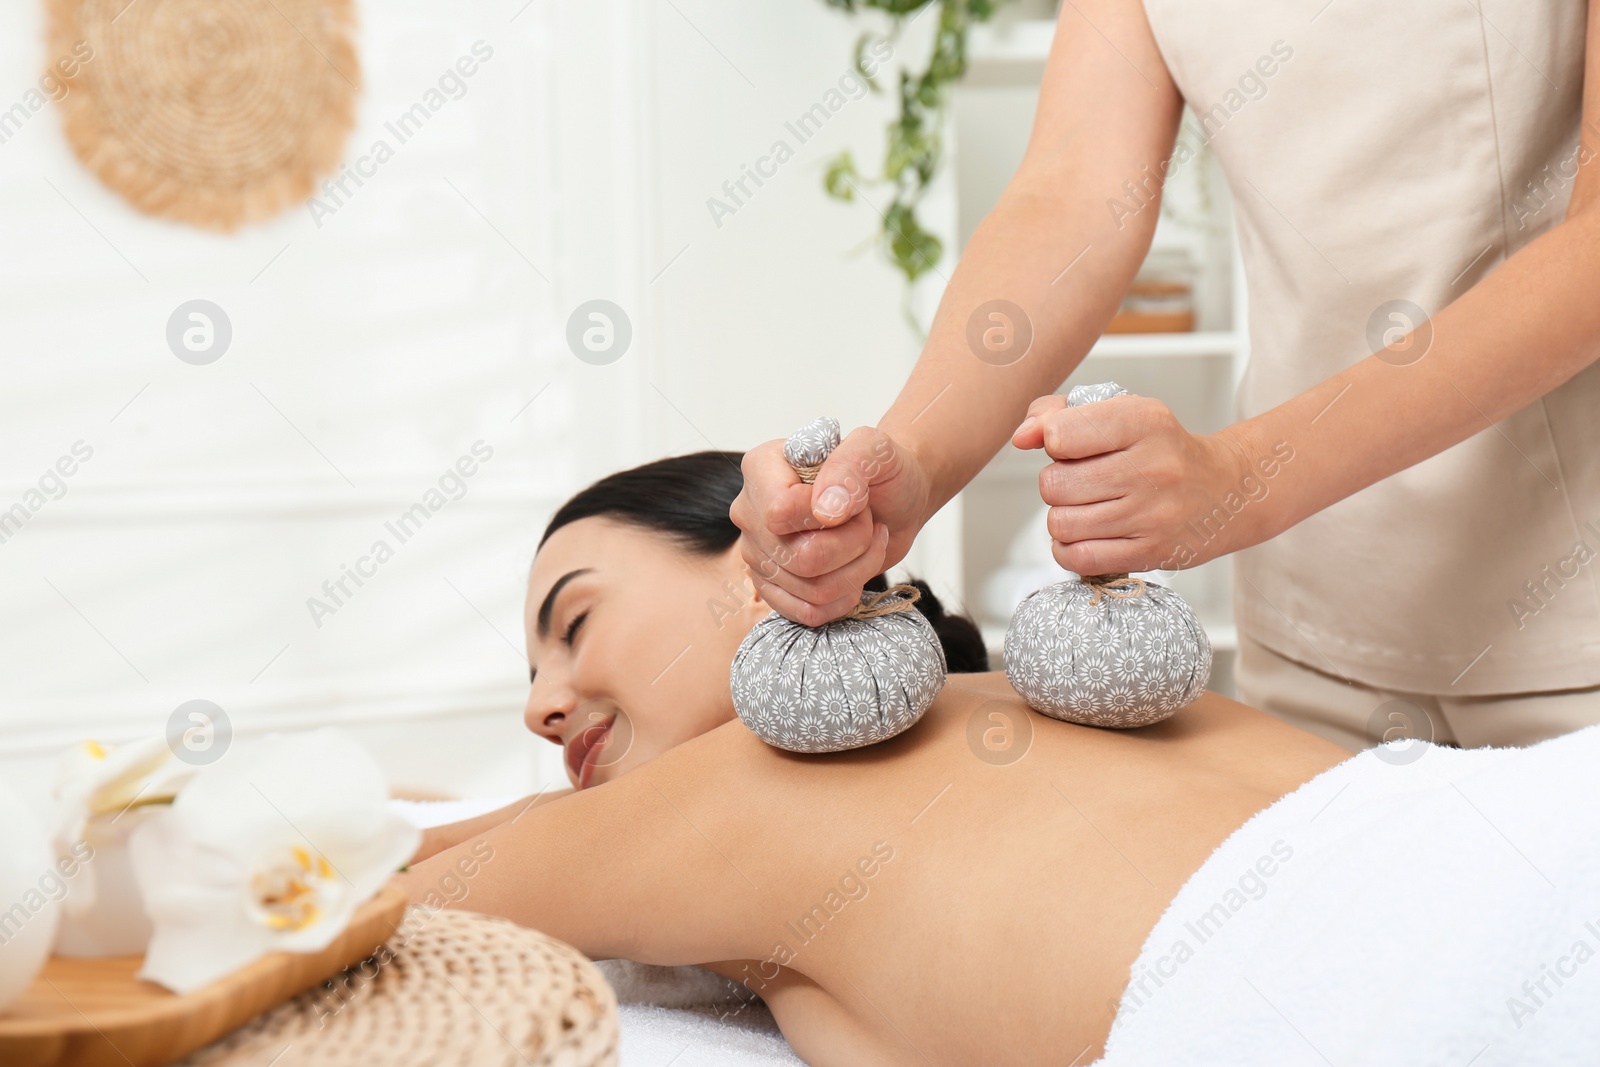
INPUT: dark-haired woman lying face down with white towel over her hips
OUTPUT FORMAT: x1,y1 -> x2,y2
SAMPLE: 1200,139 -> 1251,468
400,453 -> 1600,1067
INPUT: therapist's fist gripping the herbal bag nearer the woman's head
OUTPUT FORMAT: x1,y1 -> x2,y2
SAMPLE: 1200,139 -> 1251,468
728,427 -> 931,625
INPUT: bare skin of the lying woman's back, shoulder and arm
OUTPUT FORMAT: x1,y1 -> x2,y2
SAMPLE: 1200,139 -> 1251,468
400,672 -> 1349,1067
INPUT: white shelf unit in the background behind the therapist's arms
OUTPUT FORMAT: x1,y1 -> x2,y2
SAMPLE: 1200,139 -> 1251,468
950,16 -> 1250,694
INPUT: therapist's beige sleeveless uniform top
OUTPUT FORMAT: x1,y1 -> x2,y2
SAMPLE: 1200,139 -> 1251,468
1144,0 -> 1600,694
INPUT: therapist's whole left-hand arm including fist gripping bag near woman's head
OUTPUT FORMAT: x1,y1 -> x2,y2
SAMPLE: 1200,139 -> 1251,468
730,0 -> 1182,625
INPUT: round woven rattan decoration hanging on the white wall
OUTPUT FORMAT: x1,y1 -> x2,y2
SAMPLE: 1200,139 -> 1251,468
46,0 -> 362,230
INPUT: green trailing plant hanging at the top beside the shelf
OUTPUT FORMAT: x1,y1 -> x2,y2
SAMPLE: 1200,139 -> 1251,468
822,0 -> 1010,282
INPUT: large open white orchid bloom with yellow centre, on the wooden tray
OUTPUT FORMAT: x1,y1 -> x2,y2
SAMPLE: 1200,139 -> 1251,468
128,726 -> 421,993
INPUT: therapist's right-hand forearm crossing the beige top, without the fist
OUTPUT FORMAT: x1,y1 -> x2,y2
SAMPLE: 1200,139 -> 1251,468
1224,203 -> 1600,542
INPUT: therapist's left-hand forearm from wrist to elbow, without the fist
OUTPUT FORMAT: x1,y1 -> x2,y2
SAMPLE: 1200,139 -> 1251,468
878,170 -> 1158,515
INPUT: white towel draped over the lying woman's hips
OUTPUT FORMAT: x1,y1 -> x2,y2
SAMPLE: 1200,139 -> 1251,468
1099,726 -> 1600,1067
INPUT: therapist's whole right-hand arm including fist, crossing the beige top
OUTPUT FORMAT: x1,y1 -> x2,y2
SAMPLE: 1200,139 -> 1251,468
1013,0 -> 1600,574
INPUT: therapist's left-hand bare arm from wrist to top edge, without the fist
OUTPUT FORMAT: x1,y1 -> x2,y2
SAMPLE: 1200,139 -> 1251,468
876,0 -> 1182,515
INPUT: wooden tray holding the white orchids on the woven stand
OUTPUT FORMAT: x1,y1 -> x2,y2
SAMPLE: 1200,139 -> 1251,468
0,886 -> 406,1067
